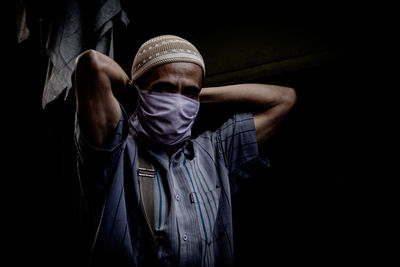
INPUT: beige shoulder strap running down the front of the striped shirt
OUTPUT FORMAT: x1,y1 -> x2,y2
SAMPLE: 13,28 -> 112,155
137,153 -> 156,232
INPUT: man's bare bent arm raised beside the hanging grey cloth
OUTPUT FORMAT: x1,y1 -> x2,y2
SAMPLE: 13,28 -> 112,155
73,50 -> 133,147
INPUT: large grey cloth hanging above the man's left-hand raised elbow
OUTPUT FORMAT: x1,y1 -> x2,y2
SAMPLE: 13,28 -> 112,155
42,0 -> 129,108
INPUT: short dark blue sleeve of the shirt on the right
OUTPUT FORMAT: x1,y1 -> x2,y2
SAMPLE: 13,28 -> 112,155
216,113 -> 270,192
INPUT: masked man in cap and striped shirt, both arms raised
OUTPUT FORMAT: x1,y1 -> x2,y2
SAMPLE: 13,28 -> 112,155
74,35 -> 296,266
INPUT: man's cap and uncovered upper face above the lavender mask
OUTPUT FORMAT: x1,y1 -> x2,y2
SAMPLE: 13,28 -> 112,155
132,35 -> 205,98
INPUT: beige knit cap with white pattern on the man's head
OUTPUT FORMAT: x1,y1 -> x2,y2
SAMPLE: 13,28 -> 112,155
131,35 -> 206,81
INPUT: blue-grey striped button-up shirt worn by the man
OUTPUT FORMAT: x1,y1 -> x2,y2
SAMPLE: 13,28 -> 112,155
75,113 -> 269,266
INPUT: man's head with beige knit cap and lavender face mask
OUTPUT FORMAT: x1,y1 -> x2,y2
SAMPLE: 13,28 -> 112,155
132,35 -> 205,151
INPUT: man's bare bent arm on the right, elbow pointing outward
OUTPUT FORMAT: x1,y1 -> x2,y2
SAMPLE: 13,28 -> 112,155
200,84 -> 296,144
